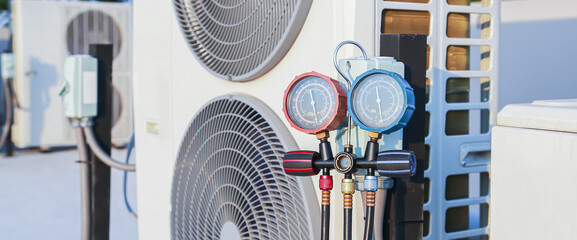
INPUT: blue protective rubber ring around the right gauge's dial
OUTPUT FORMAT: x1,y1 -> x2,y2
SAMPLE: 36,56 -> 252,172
347,69 -> 415,134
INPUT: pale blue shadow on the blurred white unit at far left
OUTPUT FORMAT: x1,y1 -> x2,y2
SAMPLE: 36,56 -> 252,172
26,58 -> 58,147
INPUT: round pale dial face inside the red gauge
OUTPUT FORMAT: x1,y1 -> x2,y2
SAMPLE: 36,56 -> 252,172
287,76 -> 336,130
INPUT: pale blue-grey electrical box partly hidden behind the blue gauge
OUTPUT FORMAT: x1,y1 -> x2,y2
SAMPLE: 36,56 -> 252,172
336,57 -> 405,157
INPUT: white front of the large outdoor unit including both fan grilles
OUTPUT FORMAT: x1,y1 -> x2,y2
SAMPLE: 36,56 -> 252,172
134,0 -> 392,239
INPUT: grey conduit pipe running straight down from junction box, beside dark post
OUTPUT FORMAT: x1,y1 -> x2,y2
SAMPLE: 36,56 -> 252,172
76,127 -> 92,240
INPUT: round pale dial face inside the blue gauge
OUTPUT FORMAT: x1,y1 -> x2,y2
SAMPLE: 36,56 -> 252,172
351,73 -> 405,129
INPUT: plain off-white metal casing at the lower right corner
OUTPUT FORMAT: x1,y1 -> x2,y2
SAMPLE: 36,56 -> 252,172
490,99 -> 577,240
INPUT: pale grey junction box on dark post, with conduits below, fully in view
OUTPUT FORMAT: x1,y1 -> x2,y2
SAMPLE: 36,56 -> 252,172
59,55 -> 98,118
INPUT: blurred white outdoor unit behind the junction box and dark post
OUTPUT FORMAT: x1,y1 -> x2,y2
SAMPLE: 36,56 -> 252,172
12,0 -> 133,148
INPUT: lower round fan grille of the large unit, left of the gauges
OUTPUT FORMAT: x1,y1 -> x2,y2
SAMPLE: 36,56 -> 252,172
171,96 -> 312,239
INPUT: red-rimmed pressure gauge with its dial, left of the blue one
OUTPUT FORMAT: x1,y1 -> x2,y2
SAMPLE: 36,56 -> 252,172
283,72 -> 347,134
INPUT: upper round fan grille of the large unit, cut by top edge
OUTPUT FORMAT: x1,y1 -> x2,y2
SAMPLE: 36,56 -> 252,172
174,0 -> 311,81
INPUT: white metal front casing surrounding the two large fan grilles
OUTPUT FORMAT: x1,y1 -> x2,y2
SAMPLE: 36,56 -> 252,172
134,0 -> 384,239
